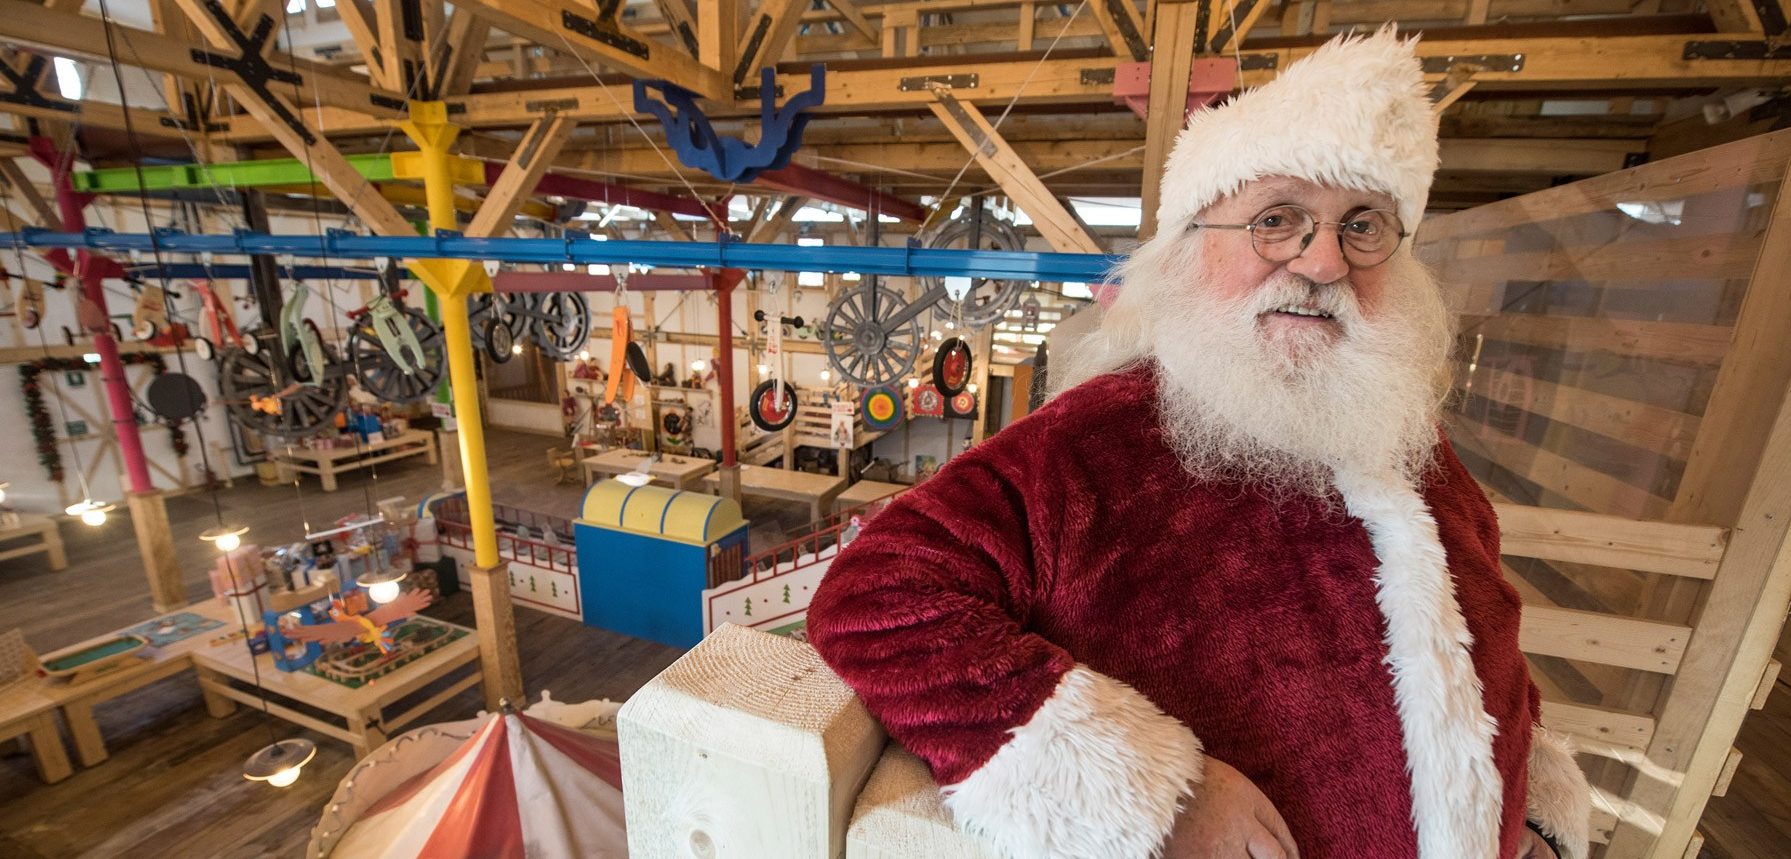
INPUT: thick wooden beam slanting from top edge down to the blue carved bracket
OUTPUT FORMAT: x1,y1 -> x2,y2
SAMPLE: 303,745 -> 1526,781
457,0 -> 734,99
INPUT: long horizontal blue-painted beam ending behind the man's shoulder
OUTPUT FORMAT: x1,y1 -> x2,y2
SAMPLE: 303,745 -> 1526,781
0,227 -> 1121,283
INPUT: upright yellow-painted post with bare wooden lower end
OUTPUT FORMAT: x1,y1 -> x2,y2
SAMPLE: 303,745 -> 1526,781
401,102 -> 525,710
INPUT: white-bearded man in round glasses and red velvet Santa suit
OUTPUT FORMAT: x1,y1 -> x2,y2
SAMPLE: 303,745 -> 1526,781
808,30 -> 1589,859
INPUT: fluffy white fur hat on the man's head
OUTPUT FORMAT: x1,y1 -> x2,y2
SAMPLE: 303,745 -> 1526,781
1157,25 -> 1436,234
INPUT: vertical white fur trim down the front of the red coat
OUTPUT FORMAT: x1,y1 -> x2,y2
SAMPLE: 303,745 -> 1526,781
1336,472 -> 1504,859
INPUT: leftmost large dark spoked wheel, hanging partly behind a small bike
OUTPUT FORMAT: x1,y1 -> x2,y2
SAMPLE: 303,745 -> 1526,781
219,331 -> 347,438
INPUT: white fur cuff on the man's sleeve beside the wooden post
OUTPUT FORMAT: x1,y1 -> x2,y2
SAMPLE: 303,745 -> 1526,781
944,666 -> 1204,859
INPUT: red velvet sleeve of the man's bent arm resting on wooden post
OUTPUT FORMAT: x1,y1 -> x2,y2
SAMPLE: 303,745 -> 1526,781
808,445 -> 1075,784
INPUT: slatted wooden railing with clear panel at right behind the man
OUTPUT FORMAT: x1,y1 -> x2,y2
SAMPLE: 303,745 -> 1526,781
1415,131 -> 1791,859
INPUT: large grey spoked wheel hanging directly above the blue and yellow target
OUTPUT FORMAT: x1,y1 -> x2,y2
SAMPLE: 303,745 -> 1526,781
820,283 -> 921,388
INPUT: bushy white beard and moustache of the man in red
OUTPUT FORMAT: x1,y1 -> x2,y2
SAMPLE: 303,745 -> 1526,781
1148,254 -> 1451,498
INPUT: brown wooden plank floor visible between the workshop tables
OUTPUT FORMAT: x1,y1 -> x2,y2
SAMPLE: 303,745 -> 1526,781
0,431 -> 806,859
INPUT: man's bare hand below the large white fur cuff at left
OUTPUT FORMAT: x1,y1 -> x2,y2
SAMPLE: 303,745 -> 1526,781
1162,757 -> 1300,859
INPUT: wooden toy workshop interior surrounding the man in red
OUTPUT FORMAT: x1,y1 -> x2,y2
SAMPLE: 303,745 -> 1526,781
0,0 -> 1791,859
